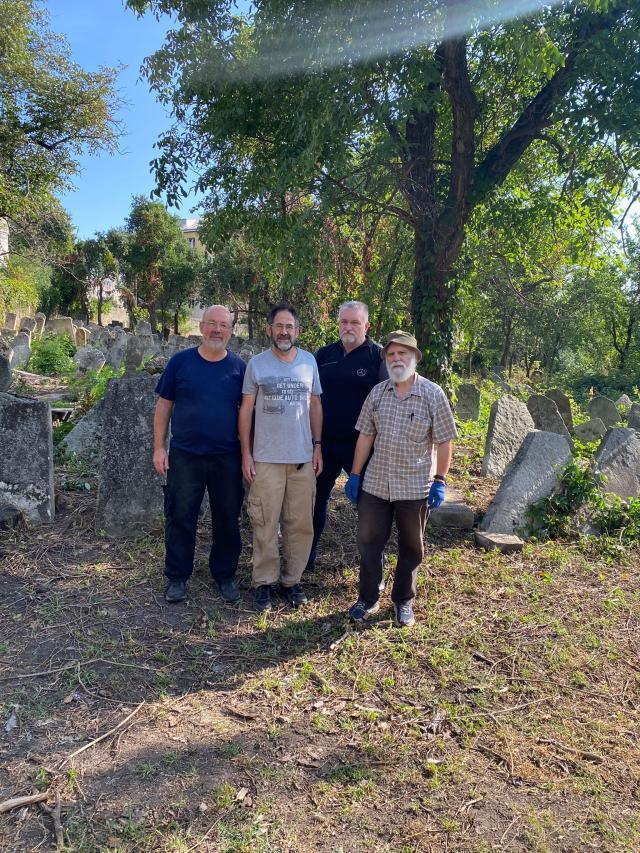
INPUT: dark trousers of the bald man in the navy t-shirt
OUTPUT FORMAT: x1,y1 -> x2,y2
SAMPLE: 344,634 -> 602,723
164,449 -> 244,583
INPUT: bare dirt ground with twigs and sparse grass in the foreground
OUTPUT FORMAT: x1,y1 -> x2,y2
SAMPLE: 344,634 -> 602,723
0,436 -> 640,853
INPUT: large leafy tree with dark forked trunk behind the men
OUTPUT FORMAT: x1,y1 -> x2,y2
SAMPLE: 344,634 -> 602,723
128,0 -> 640,378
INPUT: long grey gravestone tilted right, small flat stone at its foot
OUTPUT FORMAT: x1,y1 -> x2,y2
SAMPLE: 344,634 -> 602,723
480,430 -> 571,533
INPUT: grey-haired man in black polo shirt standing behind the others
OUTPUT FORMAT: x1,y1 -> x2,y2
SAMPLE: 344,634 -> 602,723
307,301 -> 388,570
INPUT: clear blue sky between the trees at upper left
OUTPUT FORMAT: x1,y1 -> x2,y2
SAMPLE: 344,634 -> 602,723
48,0 -> 193,238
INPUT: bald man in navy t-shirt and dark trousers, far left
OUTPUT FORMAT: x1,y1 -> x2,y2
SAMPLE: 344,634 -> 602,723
153,305 -> 245,603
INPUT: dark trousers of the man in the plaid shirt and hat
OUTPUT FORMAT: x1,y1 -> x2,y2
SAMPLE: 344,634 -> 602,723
357,491 -> 429,604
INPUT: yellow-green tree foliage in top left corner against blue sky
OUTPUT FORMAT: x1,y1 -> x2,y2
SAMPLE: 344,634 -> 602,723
0,0 -> 118,228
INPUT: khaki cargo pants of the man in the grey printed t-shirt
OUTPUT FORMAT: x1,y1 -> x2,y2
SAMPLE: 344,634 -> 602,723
247,462 -> 316,587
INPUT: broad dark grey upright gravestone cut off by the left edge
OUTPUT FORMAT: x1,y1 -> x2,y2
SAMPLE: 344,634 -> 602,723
0,393 -> 55,523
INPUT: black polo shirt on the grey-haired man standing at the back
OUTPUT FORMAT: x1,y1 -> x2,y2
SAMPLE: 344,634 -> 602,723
316,337 -> 388,452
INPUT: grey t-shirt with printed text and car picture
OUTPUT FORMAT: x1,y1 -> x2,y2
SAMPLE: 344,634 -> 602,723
242,349 -> 322,465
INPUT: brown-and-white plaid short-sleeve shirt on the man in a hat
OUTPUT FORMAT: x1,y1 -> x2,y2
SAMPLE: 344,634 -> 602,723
356,373 -> 458,501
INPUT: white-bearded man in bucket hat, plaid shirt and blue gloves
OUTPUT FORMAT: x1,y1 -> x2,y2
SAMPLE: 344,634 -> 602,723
345,330 -> 457,627
